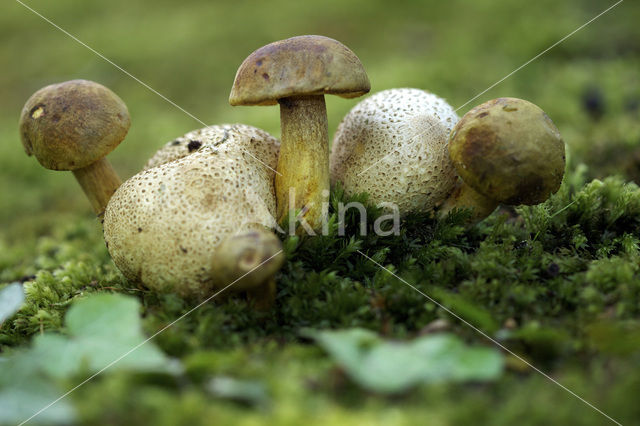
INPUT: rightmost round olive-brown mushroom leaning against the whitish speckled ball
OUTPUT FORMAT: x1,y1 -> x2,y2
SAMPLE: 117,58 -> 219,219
440,98 -> 565,221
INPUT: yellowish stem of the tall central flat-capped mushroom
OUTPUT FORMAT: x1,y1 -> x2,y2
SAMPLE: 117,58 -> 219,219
275,95 -> 329,230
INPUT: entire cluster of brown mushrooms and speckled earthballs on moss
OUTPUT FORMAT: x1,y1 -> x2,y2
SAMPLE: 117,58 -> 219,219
20,36 -> 565,307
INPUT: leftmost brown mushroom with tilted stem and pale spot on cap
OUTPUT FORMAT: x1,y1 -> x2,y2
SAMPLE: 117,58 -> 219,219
20,80 -> 131,217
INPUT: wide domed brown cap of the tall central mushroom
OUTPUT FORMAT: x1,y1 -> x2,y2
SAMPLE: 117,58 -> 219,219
229,35 -> 371,106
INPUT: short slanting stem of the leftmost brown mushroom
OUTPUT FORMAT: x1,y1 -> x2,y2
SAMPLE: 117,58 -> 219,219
73,158 -> 122,218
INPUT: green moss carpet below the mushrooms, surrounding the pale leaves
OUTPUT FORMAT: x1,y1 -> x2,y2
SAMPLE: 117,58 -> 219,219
5,169 -> 640,424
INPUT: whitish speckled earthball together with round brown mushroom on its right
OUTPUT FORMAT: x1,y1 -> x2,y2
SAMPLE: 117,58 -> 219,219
331,89 -> 565,222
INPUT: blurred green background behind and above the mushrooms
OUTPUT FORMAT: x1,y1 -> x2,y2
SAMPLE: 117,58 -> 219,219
0,0 -> 640,424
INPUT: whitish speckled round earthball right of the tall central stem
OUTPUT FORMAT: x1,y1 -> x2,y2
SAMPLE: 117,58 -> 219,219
331,88 -> 458,215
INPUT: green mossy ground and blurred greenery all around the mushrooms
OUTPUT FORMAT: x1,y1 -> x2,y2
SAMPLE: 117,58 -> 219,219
0,0 -> 640,425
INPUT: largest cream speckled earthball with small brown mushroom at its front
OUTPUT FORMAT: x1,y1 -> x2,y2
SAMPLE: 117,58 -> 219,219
104,124 -> 284,304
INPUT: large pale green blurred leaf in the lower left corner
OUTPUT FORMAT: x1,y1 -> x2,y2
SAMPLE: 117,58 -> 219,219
0,294 -> 175,423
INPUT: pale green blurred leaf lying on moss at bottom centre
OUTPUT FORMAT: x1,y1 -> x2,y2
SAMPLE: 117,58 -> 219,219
303,328 -> 503,393
